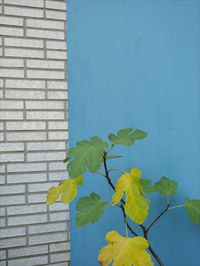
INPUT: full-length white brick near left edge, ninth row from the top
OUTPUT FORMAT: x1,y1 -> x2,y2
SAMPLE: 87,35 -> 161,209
6,79 -> 45,89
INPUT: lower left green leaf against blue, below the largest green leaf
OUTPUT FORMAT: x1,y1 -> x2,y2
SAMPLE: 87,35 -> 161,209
76,193 -> 109,226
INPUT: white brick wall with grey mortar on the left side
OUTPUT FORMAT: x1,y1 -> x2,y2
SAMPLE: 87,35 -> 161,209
0,0 -> 70,266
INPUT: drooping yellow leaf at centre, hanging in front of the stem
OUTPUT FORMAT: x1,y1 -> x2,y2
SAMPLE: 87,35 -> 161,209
112,168 -> 149,224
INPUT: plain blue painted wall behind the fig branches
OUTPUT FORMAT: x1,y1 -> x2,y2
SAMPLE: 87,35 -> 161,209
68,0 -> 200,266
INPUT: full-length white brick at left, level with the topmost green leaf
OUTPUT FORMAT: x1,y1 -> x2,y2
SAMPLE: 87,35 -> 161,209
6,132 -> 46,141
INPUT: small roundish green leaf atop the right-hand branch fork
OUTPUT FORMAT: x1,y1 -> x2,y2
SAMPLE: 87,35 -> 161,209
154,177 -> 178,196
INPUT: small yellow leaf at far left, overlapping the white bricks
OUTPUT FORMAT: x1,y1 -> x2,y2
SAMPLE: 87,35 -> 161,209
46,175 -> 83,205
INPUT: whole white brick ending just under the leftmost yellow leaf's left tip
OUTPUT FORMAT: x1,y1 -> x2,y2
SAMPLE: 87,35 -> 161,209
7,204 -> 47,215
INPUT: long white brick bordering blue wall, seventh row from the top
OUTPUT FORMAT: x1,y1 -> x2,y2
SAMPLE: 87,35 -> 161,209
27,59 -> 65,69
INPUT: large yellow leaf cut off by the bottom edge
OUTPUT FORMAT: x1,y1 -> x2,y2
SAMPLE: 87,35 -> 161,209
98,231 -> 154,266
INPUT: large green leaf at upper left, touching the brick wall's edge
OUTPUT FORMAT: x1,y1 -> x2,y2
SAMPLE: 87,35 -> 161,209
67,137 -> 108,178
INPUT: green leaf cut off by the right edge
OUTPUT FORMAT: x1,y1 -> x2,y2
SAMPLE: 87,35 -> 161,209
183,198 -> 200,225
